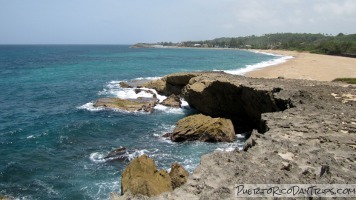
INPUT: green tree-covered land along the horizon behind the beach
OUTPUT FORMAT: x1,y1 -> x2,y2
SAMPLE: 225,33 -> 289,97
170,33 -> 356,57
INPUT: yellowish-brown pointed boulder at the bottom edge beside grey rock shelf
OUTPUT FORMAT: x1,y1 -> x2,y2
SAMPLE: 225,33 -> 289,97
121,155 -> 172,197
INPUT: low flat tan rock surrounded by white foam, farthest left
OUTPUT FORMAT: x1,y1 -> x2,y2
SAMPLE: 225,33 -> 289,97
94,98 -> 158,112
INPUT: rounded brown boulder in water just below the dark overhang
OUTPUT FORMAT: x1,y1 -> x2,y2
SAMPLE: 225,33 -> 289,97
171,114 -> 235,142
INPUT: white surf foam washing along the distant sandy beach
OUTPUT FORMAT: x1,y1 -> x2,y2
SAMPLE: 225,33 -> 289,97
224,51 -> 294,75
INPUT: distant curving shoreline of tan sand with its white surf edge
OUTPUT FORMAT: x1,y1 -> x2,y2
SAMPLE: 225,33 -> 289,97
135,46 -> 356,81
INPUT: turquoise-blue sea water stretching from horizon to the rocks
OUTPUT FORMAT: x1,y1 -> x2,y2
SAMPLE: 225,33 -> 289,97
0,45 -> 276,199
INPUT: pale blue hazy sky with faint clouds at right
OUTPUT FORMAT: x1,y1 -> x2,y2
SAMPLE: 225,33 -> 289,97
0,0 -> 356,44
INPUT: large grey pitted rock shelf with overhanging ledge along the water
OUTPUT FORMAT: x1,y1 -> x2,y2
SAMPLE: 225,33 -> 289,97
112,72 -> 356,199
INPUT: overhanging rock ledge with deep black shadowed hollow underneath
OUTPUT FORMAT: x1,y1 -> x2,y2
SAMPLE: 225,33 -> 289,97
183,73 -> 293,132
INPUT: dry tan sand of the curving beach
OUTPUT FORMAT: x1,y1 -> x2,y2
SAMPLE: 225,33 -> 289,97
245,50 -> 356,81
